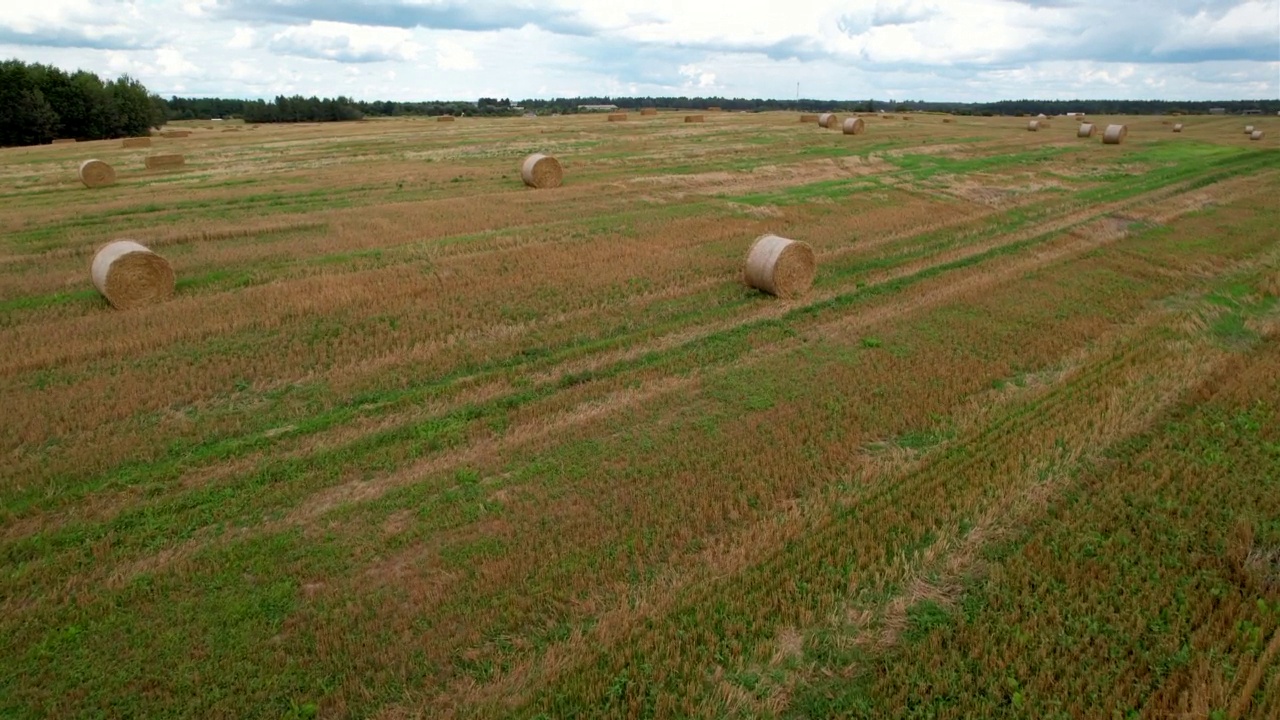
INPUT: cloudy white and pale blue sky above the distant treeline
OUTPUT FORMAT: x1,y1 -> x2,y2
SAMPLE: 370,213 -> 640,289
0,0 -> 1280,102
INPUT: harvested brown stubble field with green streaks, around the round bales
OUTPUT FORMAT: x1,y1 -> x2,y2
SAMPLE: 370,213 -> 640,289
0,107 -> 1280,720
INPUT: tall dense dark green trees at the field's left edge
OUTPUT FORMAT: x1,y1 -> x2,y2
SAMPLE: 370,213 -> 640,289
0,60 -> 168,146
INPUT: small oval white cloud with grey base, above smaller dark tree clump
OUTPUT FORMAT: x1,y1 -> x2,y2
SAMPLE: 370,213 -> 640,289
266,20 -> 419,63
